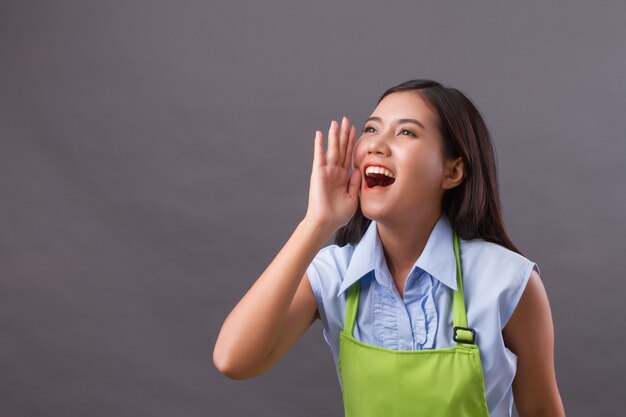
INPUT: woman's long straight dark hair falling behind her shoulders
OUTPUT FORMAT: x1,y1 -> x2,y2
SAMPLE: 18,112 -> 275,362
335,79 -> 523,255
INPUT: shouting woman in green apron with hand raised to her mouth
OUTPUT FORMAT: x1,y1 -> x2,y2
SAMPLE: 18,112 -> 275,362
213,80 -> 565,417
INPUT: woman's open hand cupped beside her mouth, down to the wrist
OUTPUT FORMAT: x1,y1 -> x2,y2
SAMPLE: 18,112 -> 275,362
305,116 -> 361,231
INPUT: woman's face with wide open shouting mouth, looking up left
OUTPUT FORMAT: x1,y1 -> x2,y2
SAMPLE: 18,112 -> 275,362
352,91 -> 452,223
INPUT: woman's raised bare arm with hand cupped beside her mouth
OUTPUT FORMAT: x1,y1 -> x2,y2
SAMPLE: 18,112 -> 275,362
213,118 -> 361,379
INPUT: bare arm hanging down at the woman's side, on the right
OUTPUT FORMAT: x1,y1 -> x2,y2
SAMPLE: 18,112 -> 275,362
502,270 -> 565,417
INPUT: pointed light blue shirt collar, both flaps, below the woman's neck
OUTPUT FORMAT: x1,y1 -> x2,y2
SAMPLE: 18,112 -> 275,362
337,213 -> 457,297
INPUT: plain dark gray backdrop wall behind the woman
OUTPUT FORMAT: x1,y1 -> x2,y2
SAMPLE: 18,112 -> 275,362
0,1 -> 626,417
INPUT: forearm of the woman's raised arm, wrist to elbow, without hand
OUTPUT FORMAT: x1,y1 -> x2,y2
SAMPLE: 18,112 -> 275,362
213,218 -> 333,375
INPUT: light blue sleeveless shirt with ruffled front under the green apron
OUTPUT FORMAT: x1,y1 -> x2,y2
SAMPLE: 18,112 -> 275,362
306,213 -> 539,417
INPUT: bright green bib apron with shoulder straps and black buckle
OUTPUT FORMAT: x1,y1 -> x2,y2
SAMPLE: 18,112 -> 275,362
338,229 -> 489,417
